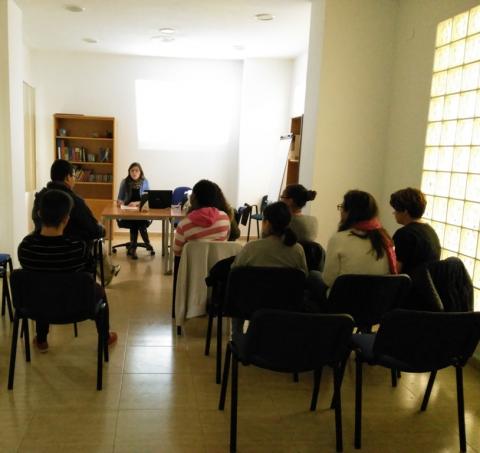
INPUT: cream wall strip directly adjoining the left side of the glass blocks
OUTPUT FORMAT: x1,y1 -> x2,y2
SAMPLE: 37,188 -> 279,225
382,0 -> 478,232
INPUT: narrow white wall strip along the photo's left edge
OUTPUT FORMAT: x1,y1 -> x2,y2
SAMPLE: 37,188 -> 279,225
0,0 -> 27,259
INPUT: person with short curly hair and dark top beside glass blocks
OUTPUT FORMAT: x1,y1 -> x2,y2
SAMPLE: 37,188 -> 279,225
390,187 -> 441,274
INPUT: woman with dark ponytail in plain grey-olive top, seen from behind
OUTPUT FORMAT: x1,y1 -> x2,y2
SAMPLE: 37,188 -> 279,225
232,201 -> 308,274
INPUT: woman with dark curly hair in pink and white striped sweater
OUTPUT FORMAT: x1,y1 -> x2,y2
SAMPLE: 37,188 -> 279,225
173,179 -> 230,256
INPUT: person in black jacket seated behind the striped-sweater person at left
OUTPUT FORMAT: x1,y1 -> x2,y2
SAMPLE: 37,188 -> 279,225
32,159 -> 120,285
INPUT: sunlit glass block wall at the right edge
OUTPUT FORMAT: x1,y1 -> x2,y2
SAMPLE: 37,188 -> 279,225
422,6 -> 480,310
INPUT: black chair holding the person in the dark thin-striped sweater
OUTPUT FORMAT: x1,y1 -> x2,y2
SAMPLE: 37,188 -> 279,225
8,269 -> 108,390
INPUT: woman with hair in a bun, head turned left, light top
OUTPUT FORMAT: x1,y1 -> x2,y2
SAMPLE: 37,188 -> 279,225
280,184 -> 318,241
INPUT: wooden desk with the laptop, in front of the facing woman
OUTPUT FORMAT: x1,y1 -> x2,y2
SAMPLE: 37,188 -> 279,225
102,202 -> 185,275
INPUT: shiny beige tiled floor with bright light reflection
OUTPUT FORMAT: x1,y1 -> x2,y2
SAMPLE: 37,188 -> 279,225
0,235 -> 480,453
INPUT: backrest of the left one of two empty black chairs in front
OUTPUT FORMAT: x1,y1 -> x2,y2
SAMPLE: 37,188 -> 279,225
240,310 -> 354,372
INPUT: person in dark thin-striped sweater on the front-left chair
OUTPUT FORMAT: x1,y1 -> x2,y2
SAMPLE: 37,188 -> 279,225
18,189 -> 117,352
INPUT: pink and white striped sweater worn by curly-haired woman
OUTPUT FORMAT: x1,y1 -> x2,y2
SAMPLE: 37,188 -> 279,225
173,208 -> 230,256
